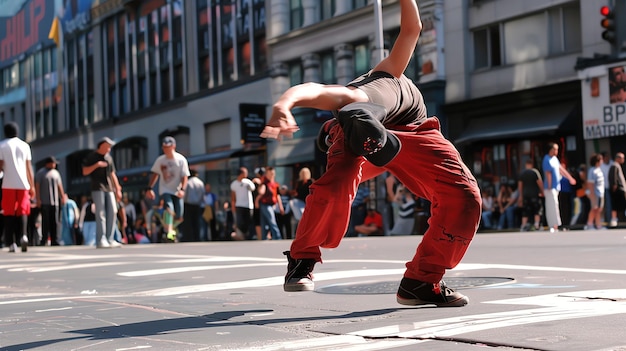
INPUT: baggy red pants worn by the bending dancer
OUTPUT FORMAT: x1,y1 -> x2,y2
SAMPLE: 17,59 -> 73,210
291,117 -> 481,283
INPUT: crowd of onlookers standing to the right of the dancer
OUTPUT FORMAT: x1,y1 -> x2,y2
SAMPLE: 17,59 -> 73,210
481,142 -> 626,233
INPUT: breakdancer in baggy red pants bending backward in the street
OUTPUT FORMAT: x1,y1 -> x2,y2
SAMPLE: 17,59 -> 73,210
261,0 -> 481,306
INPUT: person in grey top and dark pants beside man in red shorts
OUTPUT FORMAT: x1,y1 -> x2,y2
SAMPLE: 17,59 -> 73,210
35,156 -> 65,246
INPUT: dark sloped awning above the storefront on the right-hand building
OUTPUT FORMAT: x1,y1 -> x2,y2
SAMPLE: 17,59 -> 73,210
454,104 -> 574,144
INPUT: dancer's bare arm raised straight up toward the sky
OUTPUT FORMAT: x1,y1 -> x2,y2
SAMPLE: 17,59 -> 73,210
374,0 -> 422,78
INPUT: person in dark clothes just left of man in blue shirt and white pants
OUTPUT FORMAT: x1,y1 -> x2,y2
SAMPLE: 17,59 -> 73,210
517,158 -> 543,232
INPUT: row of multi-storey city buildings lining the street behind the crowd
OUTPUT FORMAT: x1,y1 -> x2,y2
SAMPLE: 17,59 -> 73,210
0,0 -> 624,214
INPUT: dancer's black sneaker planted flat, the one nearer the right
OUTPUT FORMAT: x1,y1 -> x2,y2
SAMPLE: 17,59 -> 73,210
396,278 -> 469,307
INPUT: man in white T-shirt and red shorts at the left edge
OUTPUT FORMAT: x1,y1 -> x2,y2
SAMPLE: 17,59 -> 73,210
0,122 -> 36,252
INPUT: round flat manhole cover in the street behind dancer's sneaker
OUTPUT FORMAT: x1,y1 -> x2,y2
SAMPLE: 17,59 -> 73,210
315,277 -> 515,295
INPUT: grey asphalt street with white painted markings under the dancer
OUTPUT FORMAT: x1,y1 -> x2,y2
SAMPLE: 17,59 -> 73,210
0,229 -> 626,351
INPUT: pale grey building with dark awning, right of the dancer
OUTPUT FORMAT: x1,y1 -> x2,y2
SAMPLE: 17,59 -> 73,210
444,0 -> 624,194
